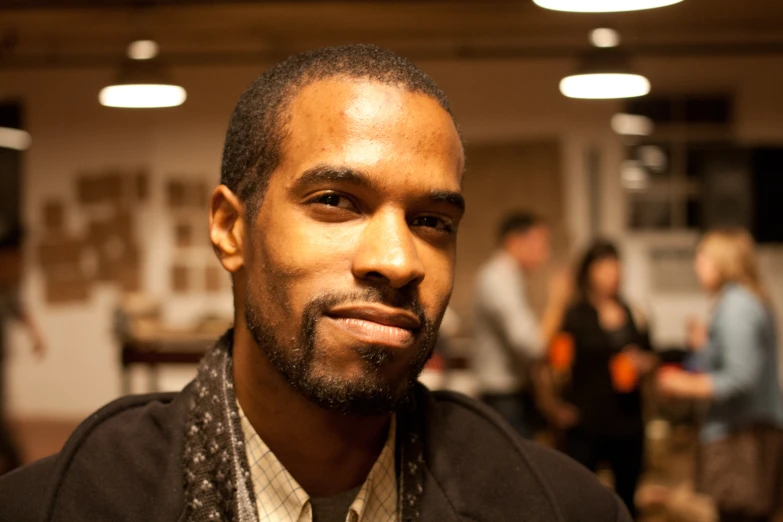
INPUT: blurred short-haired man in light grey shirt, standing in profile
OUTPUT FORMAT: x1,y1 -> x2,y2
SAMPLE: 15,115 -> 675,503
472,212 -> 570,438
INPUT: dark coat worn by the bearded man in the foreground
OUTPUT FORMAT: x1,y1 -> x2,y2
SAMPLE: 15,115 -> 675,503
0,378 -> 630,522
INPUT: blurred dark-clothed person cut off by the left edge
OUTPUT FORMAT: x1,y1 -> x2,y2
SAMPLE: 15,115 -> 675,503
0,230 -> 44,475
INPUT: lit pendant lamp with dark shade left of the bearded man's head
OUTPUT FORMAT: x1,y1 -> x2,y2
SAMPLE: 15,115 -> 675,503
98,40 -> 187,109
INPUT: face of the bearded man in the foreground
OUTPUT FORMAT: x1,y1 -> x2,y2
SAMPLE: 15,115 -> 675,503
239,77 -> 463,414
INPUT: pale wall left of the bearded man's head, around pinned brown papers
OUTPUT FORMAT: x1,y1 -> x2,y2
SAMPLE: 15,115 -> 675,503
2,65 -> 247,417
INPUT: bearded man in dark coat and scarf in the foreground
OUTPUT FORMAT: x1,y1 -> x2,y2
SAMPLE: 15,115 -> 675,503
0,45 -> 629,522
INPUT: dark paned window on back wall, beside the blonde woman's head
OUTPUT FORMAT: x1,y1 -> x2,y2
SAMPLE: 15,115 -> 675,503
621,95 -> 750,230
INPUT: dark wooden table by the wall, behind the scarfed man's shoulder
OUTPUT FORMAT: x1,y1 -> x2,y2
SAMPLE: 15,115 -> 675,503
121,330 -> 222,395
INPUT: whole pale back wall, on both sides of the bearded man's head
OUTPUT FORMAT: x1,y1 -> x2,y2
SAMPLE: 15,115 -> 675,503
0,52 -> 783,417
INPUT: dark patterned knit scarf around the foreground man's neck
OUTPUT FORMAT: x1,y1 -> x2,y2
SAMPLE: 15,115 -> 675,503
183,330 -> 424,522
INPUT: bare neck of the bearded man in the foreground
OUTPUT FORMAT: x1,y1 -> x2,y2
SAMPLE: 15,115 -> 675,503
234,325 -> 391,497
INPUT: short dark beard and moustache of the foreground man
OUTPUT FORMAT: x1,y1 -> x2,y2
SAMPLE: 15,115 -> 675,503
245,285 -> 440,416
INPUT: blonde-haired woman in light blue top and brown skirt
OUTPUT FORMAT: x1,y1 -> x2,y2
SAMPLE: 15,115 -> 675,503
658,229 -> 783,522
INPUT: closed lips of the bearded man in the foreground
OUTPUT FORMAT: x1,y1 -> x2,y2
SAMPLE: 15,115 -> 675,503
326,305 -> 421,346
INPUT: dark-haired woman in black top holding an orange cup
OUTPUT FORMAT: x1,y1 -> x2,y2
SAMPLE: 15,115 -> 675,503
562,241 -> 656,516
